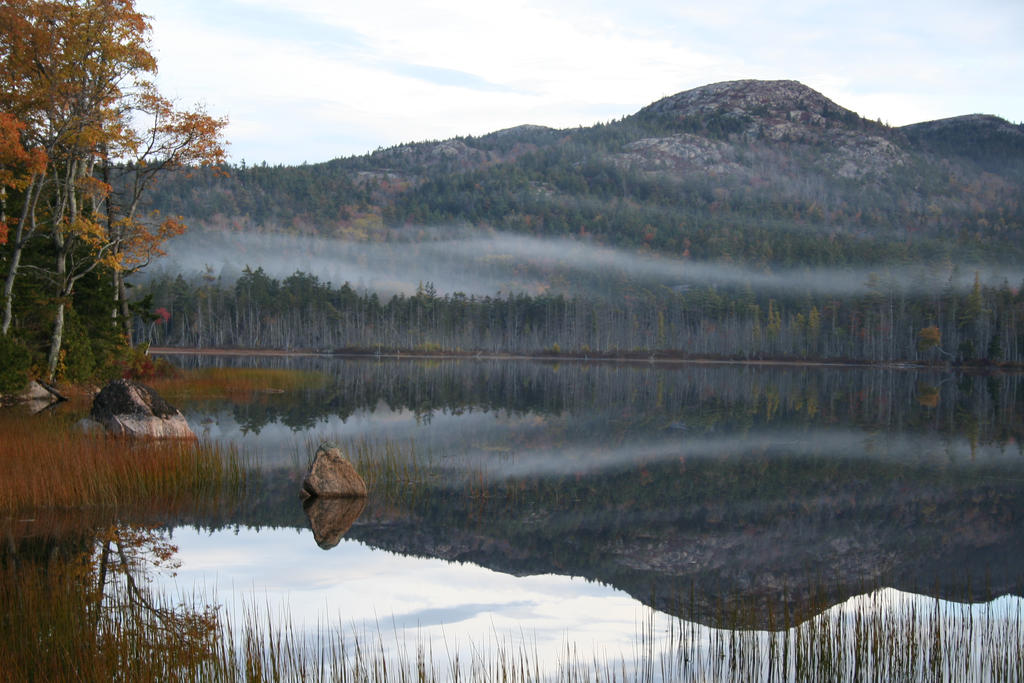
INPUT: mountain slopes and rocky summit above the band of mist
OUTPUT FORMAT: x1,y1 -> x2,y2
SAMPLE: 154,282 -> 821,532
152,80 -> 1024,266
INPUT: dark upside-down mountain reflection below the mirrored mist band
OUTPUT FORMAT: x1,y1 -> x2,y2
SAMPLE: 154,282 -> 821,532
182,448 -> 1024,627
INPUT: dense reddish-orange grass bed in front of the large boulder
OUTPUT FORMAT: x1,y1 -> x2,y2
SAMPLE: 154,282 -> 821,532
0,410 -> 246,515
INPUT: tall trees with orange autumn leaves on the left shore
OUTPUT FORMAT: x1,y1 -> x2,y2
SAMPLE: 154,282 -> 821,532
0,0 -> 226,379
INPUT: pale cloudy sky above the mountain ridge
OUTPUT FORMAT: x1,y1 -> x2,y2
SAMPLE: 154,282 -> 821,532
136,0 -> 1024,165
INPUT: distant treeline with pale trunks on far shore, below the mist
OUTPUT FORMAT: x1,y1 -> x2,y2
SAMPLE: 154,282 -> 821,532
136,267 -> 1024,362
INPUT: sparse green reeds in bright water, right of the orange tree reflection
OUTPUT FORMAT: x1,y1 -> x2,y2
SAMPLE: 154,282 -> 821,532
172,590 -> 1024,683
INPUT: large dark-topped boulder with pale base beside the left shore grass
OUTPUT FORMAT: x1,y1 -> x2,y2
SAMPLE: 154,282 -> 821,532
89,380 -> 196,439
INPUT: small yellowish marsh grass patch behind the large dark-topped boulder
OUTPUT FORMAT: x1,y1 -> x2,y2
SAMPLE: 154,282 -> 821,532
148,368 -> 329,402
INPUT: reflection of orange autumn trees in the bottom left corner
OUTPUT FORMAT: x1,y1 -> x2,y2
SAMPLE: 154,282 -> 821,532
0,513 -> 219,680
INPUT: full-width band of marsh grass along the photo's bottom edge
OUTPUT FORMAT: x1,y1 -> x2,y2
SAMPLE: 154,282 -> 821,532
0,554 -> 1024,683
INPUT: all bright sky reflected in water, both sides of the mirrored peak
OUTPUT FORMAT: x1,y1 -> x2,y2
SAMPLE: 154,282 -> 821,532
157,527 -> 1024,680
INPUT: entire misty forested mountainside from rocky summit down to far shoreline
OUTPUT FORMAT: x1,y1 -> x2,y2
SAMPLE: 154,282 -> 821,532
132,81 -> 1024,362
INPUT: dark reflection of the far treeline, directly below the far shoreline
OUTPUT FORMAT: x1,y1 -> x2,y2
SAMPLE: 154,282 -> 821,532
173,355 -> 1024,443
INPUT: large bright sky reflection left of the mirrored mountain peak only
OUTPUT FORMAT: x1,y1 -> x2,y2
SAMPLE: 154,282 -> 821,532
161,527 -> 648,660
